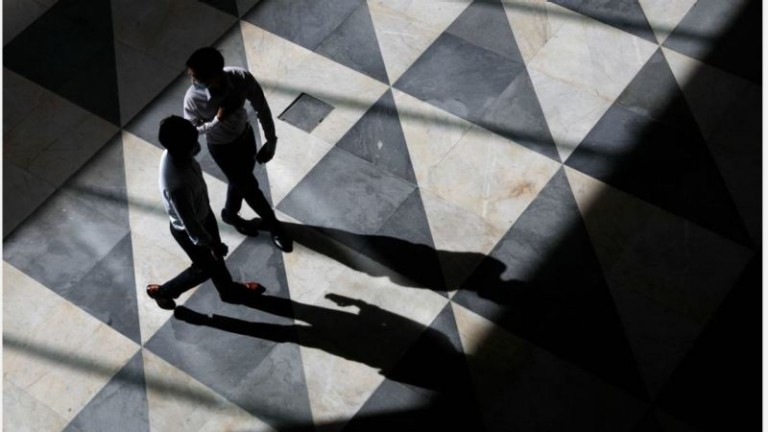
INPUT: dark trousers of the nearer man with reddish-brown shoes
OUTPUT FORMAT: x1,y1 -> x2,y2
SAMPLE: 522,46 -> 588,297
159,211 -> 236,298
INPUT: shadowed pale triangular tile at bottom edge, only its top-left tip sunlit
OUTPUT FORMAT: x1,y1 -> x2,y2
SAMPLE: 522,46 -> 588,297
453,303 -> 649,431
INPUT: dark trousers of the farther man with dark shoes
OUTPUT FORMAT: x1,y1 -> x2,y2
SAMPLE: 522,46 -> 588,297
208,126 -> 277,228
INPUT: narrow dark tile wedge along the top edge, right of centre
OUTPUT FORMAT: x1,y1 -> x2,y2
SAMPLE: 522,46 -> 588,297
550,0 -> 658,43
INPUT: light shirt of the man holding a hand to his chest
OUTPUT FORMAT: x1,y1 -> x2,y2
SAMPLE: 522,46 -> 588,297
184,67 -> 275,144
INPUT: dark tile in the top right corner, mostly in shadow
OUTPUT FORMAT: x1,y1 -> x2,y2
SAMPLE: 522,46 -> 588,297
664,0 -> 763,84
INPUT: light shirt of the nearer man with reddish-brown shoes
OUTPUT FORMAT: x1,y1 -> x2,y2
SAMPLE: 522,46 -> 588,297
159,150 -> 213,246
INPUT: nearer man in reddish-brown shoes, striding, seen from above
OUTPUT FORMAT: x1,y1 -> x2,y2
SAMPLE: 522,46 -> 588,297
147,116 -> 263,309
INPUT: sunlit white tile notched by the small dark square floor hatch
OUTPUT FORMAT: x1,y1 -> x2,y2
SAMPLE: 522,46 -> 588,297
242,19 -> 388,143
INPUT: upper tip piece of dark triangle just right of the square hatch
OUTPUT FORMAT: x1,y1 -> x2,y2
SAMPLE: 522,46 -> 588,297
336,90 -> 416,184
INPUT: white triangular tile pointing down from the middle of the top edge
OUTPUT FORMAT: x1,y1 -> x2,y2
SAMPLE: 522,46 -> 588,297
368,0 -> 468,83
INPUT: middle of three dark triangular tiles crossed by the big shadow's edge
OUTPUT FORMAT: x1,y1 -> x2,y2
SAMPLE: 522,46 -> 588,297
566,51 -> 749,244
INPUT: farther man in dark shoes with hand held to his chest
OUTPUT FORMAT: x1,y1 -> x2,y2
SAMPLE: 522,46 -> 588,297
184,47 -> 292,252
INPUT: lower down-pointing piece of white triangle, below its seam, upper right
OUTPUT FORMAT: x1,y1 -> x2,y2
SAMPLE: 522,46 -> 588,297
528,69 -> 612,160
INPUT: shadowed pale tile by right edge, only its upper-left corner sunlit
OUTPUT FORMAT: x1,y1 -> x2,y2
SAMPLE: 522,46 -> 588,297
662,48 -> 759,142
